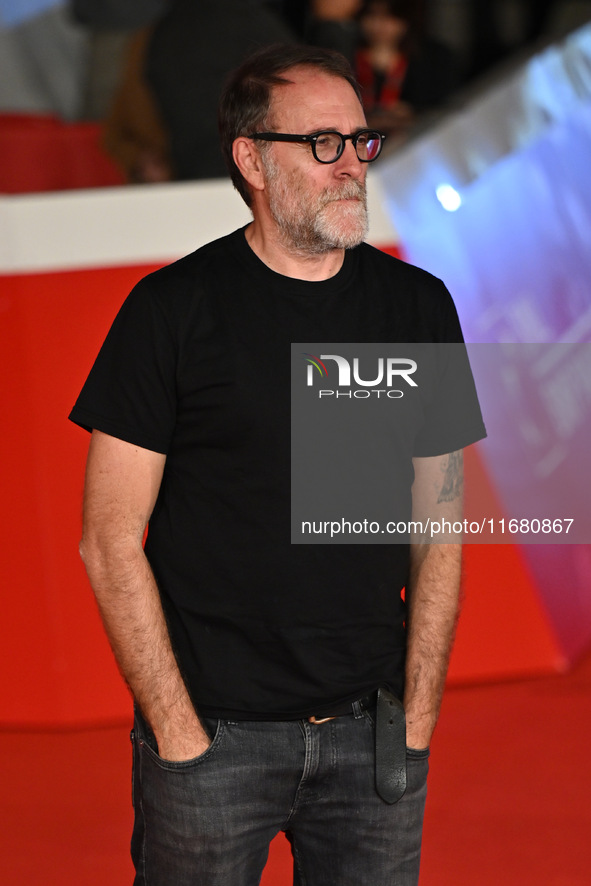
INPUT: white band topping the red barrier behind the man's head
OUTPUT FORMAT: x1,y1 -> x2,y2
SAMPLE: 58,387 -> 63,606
0,175 -> 398,273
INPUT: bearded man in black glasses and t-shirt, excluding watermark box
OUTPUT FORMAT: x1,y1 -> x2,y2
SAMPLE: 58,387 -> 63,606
71,47 -> 483,886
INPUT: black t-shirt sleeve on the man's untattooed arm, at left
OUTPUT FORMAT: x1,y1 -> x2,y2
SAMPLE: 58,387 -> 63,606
69,278 -> 179,453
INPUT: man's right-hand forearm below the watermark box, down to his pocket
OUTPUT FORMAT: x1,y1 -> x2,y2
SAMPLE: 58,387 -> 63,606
404,544 -> 461,748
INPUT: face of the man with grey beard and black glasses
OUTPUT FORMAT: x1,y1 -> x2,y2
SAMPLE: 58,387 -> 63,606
262,68 -> 367,255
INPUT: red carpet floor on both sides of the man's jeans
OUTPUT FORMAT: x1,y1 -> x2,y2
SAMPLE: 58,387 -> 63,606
0,656 -> 591,886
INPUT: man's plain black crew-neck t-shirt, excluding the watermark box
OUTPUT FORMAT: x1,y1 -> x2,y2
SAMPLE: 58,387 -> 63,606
70,230 -> 484,719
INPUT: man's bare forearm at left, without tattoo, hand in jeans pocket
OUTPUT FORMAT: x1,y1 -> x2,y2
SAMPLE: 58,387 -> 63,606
80,539 -> 209,759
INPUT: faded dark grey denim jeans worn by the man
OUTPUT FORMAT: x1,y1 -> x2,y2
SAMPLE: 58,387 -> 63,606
132,711 -> 428,886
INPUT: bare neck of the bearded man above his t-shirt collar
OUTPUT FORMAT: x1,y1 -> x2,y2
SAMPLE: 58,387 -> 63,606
245,221 -> 345,281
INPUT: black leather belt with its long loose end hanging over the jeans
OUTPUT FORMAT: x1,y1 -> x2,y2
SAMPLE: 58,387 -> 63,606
308,688 -> 406,804
